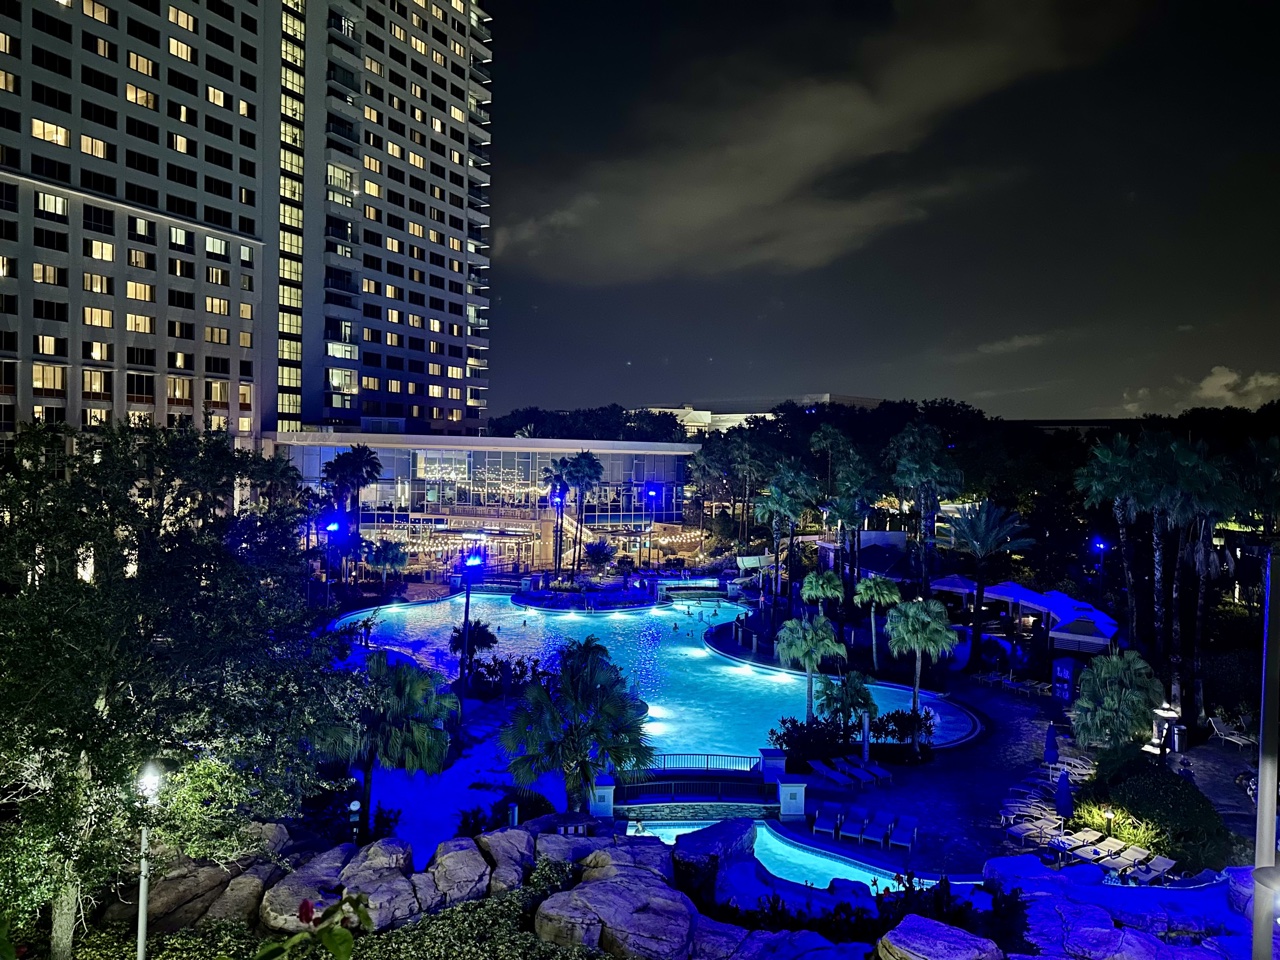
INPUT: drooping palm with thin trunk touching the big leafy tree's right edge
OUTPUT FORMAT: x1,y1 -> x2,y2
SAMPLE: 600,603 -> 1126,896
316,650 -> 458,842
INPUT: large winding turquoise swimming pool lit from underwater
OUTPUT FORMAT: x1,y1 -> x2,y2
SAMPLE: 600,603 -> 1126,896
343,594 -> 977,756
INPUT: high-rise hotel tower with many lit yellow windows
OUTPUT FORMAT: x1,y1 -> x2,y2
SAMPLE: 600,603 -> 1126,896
0,0 -> 490,443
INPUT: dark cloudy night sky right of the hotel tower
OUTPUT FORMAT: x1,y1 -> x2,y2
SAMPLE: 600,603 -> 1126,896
485,0 -> 1280,417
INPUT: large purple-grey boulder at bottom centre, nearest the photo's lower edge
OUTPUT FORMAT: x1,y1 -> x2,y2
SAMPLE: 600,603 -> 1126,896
534,872 -> 698,960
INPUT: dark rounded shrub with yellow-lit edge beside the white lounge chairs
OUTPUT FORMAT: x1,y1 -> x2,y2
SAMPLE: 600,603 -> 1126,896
1075,746 -> 1231,873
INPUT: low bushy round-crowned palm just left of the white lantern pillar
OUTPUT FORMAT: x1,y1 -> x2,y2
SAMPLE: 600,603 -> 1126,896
1071,650 -> 1165,746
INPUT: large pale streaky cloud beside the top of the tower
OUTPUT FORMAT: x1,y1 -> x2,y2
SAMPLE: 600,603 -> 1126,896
495,0 -> 1134,284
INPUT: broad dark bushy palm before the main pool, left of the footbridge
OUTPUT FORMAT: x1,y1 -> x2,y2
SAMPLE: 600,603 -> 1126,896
498,636 -> 654,810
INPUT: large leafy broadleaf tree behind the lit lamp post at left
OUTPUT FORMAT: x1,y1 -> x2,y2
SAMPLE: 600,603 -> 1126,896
0,424 -> 348,960
